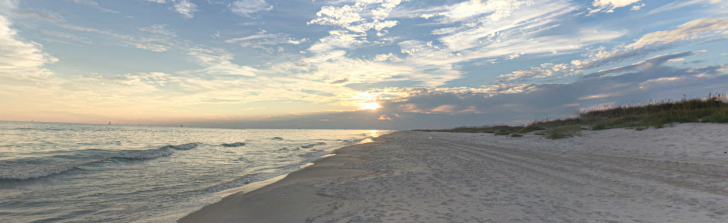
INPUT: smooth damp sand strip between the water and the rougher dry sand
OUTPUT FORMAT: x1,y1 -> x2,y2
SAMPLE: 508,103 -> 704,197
177,133 -> 391,223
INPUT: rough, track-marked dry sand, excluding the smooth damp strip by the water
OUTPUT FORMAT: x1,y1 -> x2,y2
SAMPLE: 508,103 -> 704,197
178,124 -> 728,222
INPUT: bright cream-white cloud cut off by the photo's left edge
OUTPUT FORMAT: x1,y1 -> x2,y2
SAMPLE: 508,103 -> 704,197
0,13 -> 58,78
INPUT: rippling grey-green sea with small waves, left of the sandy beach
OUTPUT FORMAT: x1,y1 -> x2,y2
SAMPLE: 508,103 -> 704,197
0,122 -> 390,223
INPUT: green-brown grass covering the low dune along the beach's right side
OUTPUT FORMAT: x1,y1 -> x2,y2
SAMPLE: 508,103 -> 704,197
416,94 -> 728,139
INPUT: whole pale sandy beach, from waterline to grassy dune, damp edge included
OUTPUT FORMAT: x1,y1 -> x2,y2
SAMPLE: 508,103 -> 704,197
179,124 -> 728,223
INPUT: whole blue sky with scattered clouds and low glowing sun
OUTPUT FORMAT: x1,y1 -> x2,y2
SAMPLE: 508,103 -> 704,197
0,0 -> 728,129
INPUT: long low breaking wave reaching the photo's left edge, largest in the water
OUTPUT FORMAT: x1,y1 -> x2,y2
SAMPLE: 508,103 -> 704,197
0,143 -> 198,180
